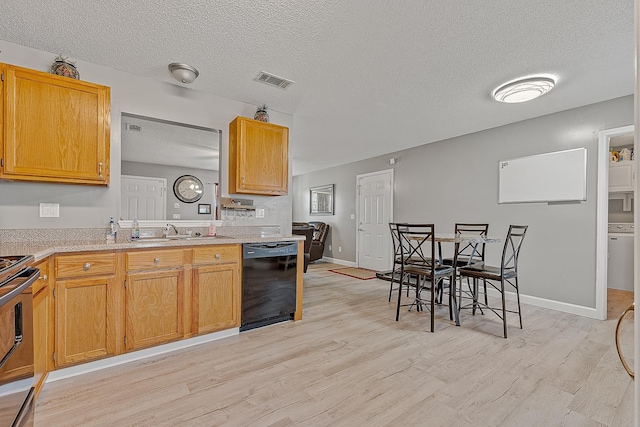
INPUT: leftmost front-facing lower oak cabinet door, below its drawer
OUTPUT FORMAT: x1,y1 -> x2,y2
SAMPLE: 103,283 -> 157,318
55,277 -> 117,367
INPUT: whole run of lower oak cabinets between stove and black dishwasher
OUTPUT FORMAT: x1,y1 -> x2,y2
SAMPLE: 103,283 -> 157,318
48,245 -> 241,372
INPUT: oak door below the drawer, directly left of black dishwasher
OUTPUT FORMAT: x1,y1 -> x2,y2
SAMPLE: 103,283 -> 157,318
191,264 -> 240,334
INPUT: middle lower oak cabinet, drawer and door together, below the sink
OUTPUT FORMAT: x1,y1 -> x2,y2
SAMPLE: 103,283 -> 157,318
125,249 -> 184,350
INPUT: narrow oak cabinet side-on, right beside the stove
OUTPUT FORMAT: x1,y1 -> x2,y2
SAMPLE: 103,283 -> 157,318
32,259 -> 53,396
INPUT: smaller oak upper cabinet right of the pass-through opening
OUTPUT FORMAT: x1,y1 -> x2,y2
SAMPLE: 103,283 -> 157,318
229,117 -> 289,196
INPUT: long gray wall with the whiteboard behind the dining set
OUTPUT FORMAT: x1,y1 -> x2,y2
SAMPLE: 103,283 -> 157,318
293,96 -> 633,307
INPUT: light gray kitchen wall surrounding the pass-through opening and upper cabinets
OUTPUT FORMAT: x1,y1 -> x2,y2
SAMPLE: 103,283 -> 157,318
0,40 -> 293,234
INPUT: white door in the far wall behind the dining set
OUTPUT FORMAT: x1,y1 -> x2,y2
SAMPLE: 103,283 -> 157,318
356,169 -> 393,271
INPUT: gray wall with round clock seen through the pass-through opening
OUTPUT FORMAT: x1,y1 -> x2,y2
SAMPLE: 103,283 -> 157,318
121,162 -> 218,221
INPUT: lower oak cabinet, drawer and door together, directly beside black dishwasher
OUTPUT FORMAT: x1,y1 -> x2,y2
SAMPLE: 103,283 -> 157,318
191,245 -> 241,334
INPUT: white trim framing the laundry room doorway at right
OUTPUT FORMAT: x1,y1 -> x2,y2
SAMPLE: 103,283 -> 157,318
596,125 -> 634,320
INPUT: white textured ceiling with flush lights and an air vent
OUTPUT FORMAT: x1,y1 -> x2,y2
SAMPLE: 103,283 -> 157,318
0,0 -> 634,174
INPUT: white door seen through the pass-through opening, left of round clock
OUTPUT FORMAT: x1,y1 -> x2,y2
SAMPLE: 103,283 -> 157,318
120,175 -> 167,220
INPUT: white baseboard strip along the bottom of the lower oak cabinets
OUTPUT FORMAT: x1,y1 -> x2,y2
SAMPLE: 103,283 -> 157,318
46,328 -> 240,382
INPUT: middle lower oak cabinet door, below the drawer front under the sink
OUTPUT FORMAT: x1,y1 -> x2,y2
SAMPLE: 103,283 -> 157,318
125,269 -> 184,350
